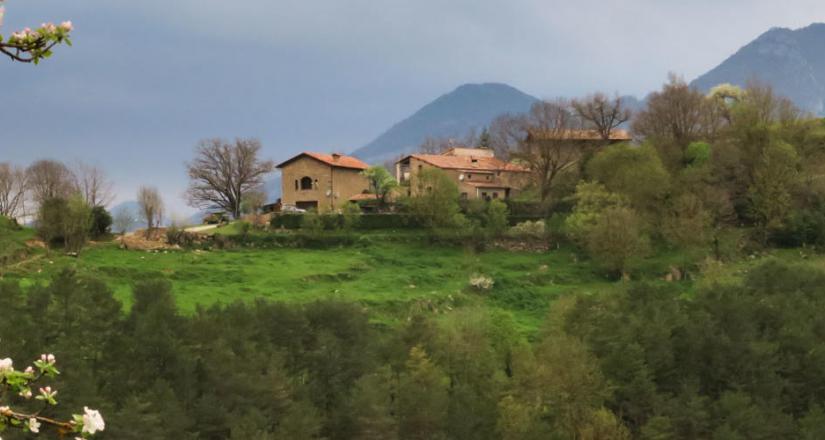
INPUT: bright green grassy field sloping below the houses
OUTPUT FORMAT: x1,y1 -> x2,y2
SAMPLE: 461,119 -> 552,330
0,220 -> 821,332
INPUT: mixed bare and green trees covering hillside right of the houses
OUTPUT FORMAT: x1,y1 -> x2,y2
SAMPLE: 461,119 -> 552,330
476,77 -> 825,276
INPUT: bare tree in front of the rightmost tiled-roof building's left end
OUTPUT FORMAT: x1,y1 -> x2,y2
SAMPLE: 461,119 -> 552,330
511,99 -> 586,201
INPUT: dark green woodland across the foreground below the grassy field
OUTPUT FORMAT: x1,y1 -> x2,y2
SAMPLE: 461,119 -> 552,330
0,262 -> 825,440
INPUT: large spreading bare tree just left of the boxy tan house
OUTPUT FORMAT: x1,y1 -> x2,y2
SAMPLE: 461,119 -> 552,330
187,139 -> 275,218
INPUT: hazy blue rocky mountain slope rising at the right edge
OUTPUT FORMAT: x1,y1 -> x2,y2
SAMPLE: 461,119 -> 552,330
691,23 -> 825,115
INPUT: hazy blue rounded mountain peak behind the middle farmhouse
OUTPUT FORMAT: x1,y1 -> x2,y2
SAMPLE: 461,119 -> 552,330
353,83 -> 537,163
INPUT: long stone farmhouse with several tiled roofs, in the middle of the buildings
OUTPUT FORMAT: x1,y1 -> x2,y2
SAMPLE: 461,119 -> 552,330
395,147 -> 529,200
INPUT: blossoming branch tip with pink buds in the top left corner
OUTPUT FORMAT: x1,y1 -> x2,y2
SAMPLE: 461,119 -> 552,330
0,0 -> 73,64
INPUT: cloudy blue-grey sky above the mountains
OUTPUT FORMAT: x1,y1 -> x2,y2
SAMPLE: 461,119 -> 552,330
0,0 -> 825,213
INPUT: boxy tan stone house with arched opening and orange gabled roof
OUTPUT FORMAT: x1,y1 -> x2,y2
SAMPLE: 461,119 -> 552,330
277,152 -> 369,213
